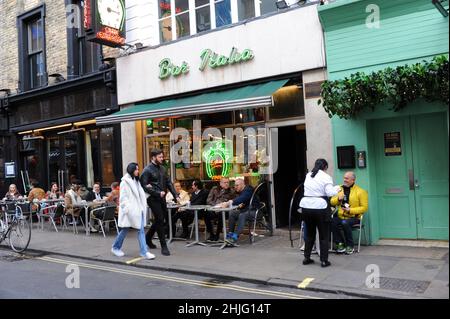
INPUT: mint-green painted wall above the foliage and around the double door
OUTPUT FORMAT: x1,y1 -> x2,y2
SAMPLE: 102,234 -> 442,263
319,0 -> 449,243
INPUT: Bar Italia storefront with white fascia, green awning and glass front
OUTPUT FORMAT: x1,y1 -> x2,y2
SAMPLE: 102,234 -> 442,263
97,1 -> 333,227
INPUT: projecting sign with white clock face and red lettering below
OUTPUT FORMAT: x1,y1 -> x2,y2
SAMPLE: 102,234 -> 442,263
83,0 -> 125,47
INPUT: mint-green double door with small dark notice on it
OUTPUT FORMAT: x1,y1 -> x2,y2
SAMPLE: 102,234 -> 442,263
372,113 -> 449,240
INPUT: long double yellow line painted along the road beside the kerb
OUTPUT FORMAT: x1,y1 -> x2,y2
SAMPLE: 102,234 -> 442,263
35,257 -> 323,299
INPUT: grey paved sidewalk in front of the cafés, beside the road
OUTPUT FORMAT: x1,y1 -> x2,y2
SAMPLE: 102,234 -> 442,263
5,226 -> 449,299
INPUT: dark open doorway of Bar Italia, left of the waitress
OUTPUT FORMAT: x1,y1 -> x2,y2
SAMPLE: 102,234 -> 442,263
273,124 -> 307,227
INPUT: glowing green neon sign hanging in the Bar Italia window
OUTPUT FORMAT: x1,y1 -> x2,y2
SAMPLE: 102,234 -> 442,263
203,141 -> 232,180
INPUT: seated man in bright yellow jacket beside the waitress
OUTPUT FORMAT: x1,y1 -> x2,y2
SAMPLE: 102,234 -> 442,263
331,172 -> 369,255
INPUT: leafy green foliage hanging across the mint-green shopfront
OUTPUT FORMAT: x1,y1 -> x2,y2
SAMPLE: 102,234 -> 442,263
318,55 -> 449,119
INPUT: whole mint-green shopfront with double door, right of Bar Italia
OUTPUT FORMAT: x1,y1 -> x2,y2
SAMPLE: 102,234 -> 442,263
319,0 -> 449,243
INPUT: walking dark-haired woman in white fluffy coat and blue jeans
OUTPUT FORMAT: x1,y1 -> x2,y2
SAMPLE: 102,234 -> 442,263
111,163 -> 155,259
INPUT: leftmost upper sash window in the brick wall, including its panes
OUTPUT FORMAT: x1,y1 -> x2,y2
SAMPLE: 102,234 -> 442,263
17,5 -> 47,90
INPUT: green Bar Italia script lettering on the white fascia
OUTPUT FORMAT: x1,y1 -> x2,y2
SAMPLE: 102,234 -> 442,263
159,47 -> 255,80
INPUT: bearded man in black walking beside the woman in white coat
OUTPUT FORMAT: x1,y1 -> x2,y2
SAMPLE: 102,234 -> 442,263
140,149 -> 179,256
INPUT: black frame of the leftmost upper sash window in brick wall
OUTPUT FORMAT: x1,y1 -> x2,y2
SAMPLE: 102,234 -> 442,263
17,3 -> 48,92
